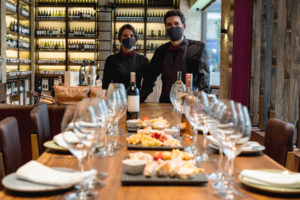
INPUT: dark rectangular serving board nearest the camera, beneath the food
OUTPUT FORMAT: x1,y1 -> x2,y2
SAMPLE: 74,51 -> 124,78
121,171 -> 208,185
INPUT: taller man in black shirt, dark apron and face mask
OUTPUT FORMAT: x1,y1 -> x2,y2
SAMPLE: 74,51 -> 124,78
140,10 -> 209,103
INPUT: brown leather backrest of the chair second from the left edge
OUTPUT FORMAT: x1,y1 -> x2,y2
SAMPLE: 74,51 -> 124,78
30,103 -> 51,154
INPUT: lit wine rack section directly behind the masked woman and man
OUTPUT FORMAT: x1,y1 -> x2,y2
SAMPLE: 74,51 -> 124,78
113,0 -> 179,59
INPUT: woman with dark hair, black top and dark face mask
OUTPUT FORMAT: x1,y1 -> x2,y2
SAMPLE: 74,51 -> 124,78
102,24 -> 149,89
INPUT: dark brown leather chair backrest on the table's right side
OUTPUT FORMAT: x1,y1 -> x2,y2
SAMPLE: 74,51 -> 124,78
264,118 -> 295,166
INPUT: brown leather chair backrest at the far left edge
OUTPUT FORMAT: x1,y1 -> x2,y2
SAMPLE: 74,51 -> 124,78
0,117 -> 22,175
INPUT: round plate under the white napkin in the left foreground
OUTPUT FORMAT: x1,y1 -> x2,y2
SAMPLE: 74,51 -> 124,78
2,168 -> 75,192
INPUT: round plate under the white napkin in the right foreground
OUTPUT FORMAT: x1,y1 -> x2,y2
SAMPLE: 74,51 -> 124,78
239,169 -> 300,194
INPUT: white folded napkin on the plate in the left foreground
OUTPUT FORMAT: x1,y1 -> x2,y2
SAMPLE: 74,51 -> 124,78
16,160 -> 96,186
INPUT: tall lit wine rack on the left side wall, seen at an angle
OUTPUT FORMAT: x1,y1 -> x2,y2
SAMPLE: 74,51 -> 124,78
5,0 -> 33,105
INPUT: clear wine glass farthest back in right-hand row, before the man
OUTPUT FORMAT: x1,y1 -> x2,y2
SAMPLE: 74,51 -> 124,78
170,82 -> 186,133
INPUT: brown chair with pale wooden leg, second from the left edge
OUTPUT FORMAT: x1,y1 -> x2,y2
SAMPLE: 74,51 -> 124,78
30,103 -> 51,159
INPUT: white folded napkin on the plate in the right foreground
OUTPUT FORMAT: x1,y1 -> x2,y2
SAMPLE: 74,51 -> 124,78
241,170 -> 300,188
